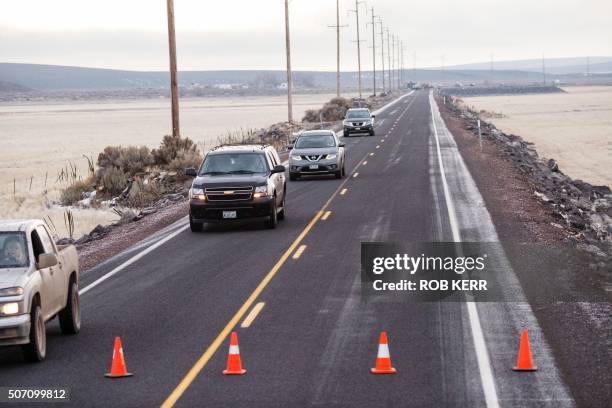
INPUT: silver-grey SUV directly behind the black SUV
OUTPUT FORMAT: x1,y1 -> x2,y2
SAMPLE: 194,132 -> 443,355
289,130 -> 346,180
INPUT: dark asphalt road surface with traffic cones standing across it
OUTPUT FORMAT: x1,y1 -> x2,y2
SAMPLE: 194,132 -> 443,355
0,91 -> 574,407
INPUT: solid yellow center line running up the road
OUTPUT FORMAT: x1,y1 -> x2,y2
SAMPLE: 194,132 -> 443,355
161,147 -> 367,408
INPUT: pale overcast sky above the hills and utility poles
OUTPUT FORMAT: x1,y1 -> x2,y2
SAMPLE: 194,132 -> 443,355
0,0 -> 612,70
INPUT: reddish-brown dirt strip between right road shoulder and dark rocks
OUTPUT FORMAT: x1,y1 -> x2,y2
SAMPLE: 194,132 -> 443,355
438,95 -> 612,407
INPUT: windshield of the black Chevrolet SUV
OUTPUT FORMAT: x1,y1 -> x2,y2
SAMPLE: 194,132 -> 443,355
200,153 -> 268,175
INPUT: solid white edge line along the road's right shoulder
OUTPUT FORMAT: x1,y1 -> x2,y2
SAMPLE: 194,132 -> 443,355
429,92 -> 499,408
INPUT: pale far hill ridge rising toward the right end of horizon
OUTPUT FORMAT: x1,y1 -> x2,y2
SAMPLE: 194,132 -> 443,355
447,57 -> 612,75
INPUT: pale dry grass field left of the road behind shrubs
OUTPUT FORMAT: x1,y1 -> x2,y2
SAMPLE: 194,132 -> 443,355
0,94 -> 352,238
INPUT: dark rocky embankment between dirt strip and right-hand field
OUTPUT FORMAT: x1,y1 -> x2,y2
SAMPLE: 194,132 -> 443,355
446,97 -> 612,270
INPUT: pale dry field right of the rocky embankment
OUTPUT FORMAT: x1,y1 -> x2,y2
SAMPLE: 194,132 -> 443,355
462,86 -> 612,186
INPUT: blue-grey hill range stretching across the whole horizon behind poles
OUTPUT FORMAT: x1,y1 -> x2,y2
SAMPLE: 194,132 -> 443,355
0,57 -> 612,93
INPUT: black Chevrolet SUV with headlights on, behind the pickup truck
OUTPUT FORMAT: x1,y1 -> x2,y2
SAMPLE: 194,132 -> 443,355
185,145 -> 287,232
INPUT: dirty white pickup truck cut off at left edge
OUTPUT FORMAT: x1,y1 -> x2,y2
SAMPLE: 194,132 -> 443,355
0,220 -> 81,361
